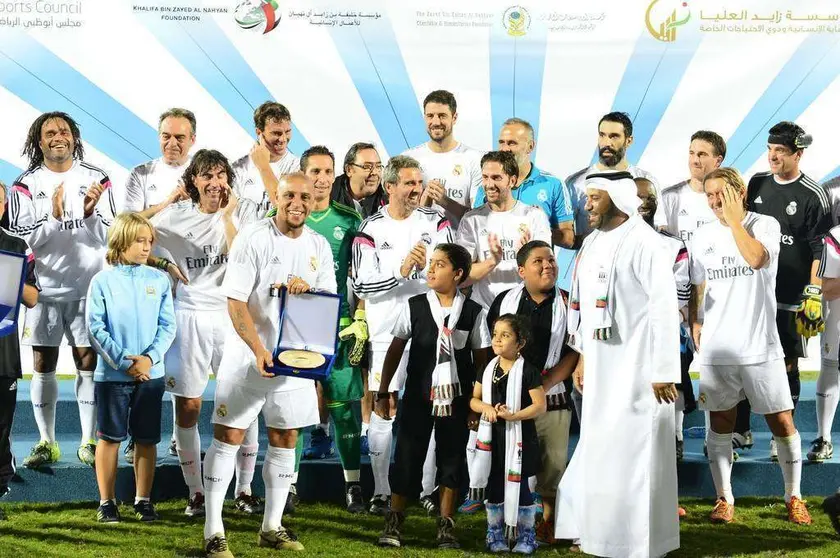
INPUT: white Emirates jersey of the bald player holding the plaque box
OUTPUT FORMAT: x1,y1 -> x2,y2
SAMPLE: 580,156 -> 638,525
219,219 -> 336,391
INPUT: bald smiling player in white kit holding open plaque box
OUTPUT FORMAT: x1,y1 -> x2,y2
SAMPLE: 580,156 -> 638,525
204,173 -> 336,558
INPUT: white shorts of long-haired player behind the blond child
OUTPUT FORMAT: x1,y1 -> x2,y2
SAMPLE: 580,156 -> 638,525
164,309 -> 230,398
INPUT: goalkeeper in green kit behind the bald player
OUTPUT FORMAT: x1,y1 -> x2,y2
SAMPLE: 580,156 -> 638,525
269,145 -> 368,513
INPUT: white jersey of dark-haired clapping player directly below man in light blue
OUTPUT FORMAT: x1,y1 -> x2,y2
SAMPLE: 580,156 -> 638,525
457,201 -> 551,308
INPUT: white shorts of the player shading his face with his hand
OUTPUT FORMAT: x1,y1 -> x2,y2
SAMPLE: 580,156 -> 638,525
697,358 -> 793,415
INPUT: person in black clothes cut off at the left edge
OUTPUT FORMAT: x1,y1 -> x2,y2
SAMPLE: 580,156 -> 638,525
0,186 -> 41,519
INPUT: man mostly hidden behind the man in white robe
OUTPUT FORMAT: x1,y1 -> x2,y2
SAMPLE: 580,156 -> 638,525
634,178 -> 697,468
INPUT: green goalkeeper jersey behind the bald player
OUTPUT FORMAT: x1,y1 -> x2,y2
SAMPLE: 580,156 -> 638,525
306,201 -> 362,318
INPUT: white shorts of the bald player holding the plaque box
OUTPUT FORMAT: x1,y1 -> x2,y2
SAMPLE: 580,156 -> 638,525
213,377 -> 321,430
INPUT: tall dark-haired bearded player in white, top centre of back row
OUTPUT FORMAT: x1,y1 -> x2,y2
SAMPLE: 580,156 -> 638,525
404,90 -> 481,227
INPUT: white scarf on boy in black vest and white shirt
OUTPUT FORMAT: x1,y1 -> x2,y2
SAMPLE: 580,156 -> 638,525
426,291 -> 466,417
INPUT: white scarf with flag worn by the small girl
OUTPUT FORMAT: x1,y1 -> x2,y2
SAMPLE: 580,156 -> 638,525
470,356 -> 525,538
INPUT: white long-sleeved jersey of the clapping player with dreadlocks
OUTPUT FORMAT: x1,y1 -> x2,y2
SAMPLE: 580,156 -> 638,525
9,161 -> 116,302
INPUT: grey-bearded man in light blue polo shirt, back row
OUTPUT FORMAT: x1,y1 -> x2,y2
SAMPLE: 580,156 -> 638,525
474,118 -> 575,248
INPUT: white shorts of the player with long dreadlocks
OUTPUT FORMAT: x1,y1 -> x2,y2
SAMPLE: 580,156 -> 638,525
20,299 -> 90,347
